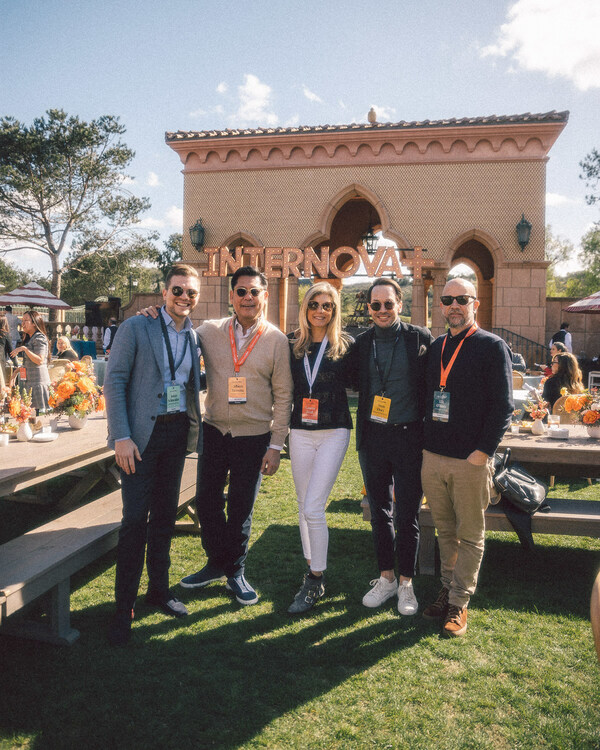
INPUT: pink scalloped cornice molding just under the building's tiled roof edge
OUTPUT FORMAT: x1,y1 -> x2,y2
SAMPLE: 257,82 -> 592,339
167,118 -> 567,173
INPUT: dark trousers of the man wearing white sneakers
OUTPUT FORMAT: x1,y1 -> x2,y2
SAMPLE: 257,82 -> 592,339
358,422 -> 423,578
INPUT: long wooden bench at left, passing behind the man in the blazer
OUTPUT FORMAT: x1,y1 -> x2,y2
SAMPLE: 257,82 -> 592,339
0,454 -> 199,645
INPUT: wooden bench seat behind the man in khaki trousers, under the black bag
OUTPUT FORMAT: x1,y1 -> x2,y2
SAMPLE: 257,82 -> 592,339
419,498 -> 600,575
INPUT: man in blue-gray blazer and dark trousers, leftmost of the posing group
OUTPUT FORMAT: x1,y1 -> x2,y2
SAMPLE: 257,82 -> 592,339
104,264 -> 202,646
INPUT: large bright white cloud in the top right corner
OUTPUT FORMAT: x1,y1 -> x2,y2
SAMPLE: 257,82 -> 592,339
480,0 -> 600,91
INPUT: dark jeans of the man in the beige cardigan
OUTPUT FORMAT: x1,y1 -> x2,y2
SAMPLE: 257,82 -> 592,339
196,422 -> 271,577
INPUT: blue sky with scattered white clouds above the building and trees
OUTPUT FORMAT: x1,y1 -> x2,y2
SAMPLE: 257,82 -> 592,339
0,0 -> 600,271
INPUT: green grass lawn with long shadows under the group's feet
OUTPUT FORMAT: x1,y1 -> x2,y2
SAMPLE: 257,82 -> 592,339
0,438 -> 600,750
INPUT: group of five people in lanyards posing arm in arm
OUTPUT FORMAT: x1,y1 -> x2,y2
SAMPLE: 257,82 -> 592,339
104,264 -> 513,645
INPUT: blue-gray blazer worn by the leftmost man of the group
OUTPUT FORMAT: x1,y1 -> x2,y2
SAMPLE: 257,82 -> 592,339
104,315 -> 202,454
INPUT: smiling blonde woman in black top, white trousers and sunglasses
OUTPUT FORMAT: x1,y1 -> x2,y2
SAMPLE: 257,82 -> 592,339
288,282 -> 352,614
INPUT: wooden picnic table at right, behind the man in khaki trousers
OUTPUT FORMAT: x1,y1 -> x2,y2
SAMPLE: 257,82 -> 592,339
498,425 -> 600,479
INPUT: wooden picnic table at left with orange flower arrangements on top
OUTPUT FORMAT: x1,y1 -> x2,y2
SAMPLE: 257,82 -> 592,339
0,414 -> 118,509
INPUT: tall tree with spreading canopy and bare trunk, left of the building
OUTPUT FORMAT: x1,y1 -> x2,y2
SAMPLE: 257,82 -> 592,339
0,109 -> 150,312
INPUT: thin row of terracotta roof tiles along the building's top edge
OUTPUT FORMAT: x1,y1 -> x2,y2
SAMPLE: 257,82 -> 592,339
165,110 -> 569,142
